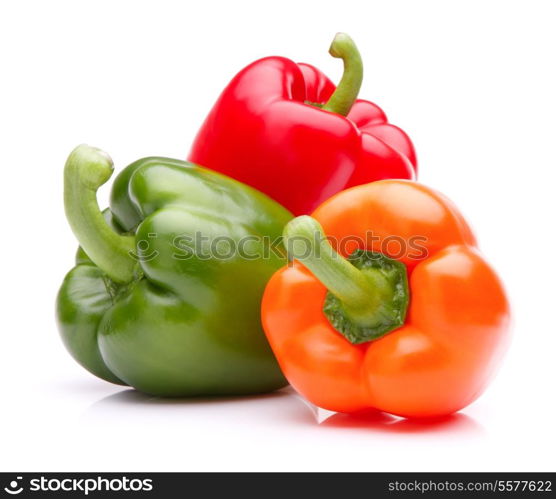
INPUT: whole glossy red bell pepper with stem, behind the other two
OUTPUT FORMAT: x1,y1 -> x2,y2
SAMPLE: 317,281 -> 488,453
189,34 -> 417,215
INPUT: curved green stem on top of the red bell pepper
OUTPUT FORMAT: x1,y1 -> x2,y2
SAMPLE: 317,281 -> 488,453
322,33 -> 363,116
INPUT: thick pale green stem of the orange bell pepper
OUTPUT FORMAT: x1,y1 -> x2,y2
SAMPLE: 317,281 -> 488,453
284,215 -> 387,326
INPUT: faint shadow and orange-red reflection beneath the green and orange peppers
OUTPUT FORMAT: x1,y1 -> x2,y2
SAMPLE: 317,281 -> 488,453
81,387 -> 484,435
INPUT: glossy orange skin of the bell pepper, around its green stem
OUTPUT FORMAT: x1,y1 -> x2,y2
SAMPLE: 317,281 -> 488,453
262,180 -> 509,417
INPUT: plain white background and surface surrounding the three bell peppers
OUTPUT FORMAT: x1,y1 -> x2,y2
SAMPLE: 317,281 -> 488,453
0,0 -> 556,471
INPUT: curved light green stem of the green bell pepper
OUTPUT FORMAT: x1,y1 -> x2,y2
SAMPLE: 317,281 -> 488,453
64,145 -> 136,283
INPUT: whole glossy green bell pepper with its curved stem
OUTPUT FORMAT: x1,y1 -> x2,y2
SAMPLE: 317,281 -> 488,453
57,146 -> 291,396
